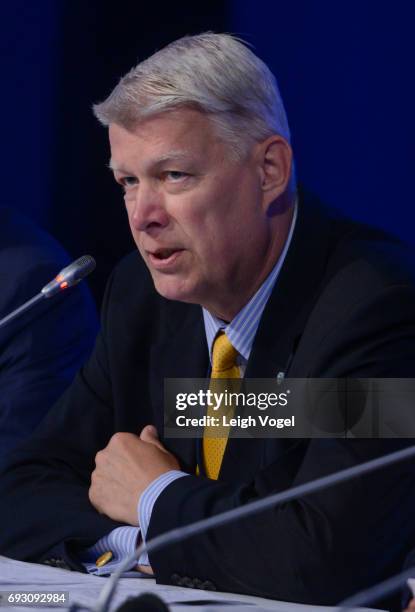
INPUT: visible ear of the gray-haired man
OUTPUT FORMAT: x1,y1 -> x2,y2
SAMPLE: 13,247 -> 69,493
259,134 -> 293,210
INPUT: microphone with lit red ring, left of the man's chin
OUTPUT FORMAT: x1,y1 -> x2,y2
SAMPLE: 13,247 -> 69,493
0,255 -> 96,328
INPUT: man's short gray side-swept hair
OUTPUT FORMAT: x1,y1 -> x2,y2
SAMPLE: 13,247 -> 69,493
93,32 -> 290,158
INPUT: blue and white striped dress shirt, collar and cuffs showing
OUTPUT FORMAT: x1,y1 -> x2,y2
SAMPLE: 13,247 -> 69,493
80,203 -> 298,576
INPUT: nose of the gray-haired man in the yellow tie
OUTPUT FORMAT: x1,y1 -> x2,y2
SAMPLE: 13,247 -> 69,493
130,183 -> 168,232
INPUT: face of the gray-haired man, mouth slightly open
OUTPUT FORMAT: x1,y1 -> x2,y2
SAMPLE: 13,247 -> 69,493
109,109 -> 270,317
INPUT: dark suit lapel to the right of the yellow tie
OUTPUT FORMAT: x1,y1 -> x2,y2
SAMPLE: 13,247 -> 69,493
220,198 -> 330,482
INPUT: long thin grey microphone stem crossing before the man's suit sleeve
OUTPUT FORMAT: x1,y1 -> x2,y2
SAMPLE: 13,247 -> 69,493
90,446 -> 415,612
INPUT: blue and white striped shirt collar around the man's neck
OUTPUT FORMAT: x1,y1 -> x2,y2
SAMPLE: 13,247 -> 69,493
202,201 -> 298,361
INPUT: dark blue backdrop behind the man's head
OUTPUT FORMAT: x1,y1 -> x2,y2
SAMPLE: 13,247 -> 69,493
0,0 -> 415,301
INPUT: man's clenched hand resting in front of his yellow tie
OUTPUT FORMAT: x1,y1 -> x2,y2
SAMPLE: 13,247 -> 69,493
88,425 -> 180,525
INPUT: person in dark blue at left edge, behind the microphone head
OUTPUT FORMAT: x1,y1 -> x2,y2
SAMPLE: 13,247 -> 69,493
0,207 -> 98,458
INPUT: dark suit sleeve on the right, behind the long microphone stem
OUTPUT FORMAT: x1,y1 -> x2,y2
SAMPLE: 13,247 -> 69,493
148,286 -> 415,605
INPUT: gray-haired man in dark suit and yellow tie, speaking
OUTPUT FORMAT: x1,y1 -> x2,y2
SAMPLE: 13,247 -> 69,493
0,33 -> 415,604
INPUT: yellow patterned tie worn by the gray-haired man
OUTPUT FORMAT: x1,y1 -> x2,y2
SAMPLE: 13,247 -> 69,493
203,332 -> 240,480
